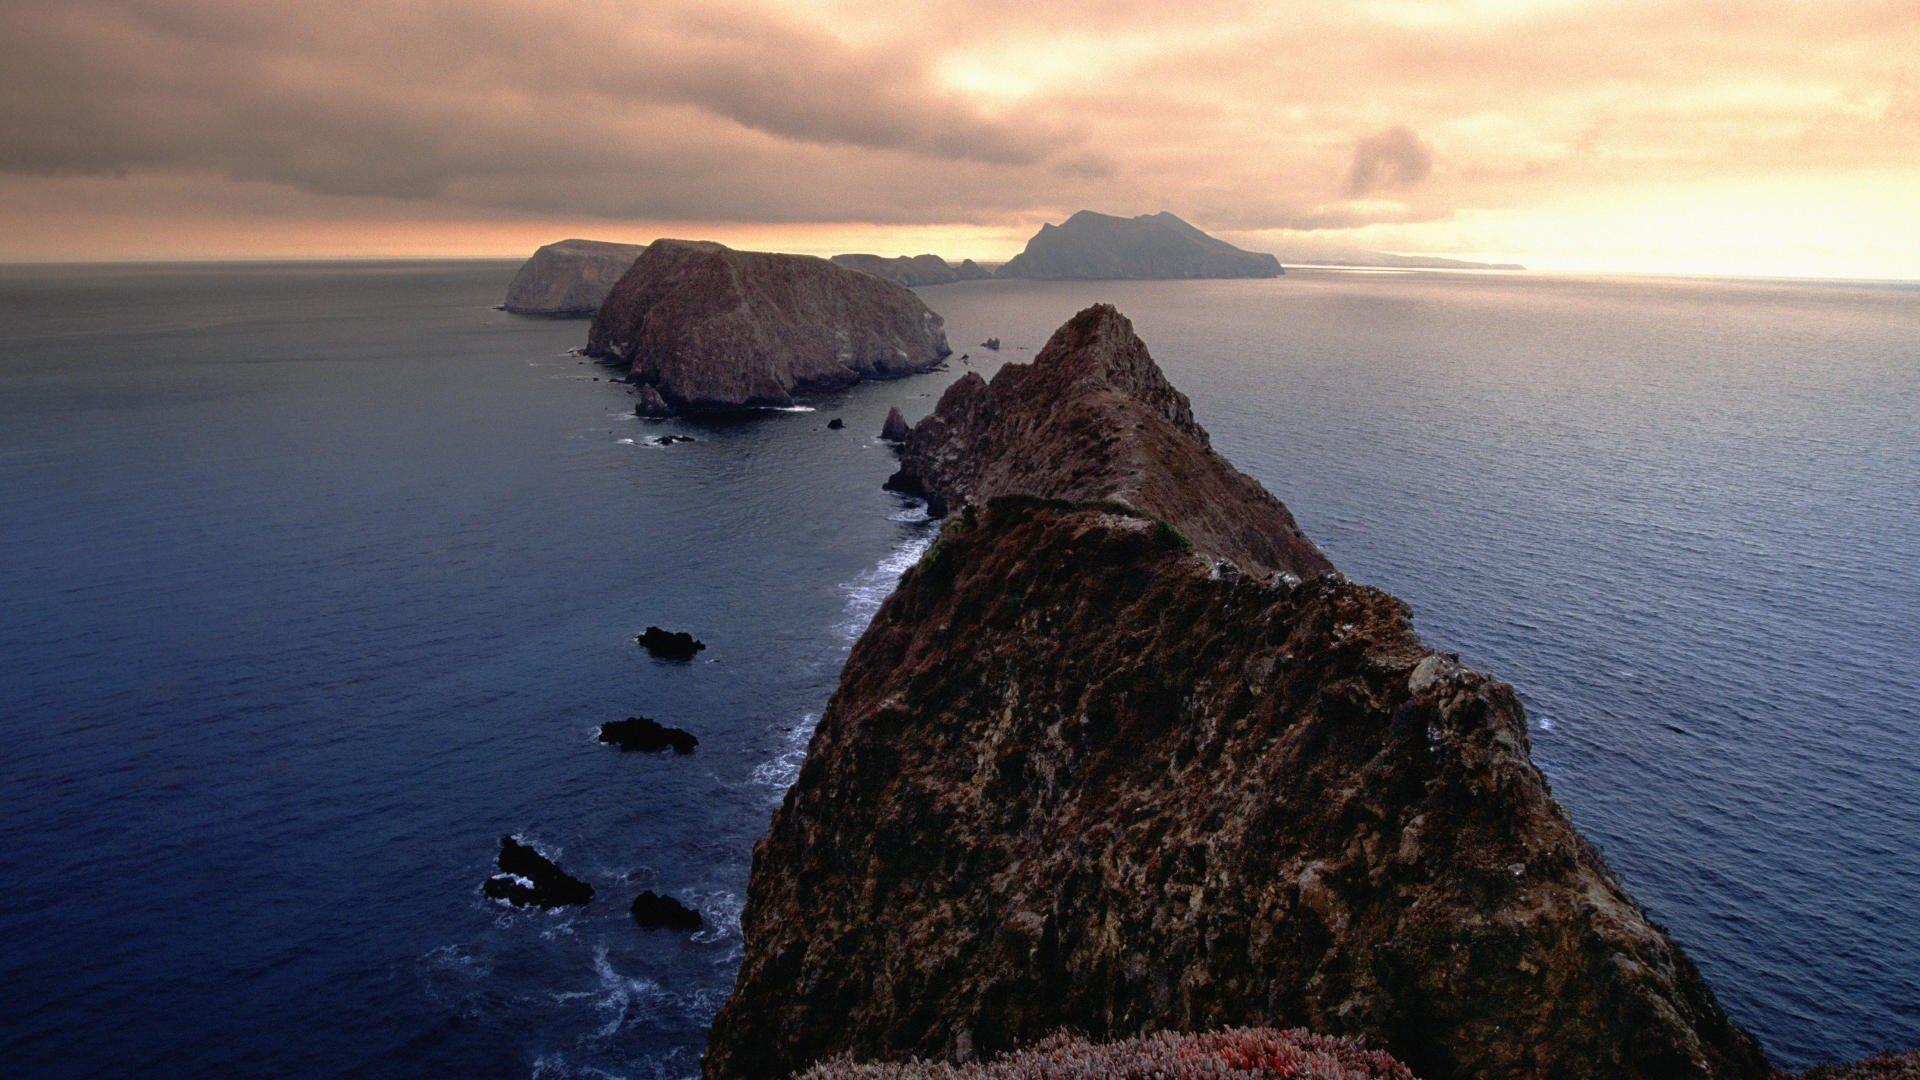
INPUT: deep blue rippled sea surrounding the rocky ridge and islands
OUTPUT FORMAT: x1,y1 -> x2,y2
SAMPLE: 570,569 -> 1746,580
0,263 -> 1920,1076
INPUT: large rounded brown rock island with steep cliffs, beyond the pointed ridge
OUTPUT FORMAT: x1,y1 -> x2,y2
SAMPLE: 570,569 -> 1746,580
588,240 -> 950,411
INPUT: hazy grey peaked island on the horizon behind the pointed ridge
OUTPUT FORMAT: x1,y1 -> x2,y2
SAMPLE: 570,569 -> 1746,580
998,209 -> 1286,281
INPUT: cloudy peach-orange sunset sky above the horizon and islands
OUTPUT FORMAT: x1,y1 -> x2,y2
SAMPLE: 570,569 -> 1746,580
0,0 -> 1920,279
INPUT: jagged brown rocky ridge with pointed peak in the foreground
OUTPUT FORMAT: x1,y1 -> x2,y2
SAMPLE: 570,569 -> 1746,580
707,307 -> 1764,1078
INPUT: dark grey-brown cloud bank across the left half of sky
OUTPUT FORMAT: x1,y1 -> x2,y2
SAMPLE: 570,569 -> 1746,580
0,0 -> 1104,215
